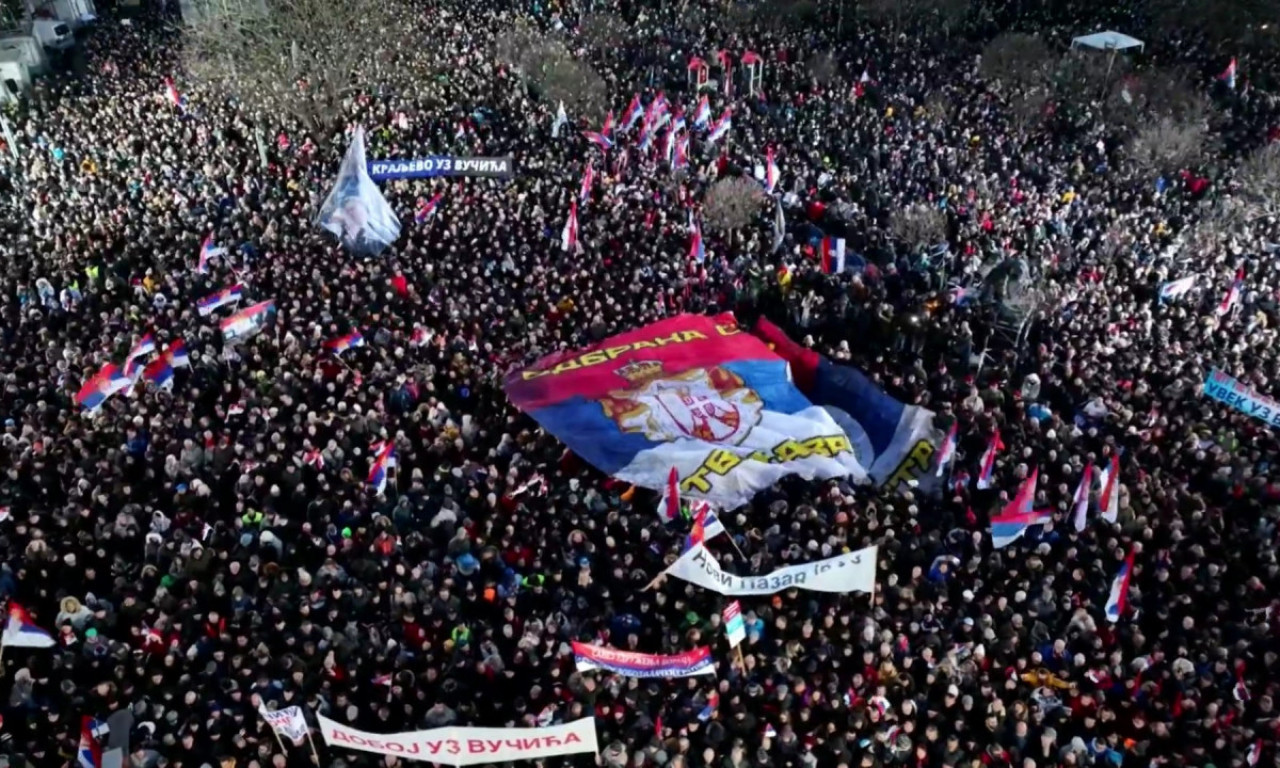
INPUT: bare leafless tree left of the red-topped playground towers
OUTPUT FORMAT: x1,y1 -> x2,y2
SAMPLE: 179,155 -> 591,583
494,26 -> 608,119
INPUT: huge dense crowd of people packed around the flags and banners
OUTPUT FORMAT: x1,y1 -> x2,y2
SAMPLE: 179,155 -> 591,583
0,0 -> 1280,768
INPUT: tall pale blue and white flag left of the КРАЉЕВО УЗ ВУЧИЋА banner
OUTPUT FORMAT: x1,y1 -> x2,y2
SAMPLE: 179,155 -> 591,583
316,125 -> 399,256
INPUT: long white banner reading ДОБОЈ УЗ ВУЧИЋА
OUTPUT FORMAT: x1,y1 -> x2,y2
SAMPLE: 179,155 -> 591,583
316,713 -> 600,765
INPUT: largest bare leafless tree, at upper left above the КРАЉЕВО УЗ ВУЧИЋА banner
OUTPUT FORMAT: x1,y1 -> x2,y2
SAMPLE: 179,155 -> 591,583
183,0 -> 409,129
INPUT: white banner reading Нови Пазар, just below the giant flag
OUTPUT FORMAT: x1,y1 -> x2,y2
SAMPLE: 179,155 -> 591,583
667,545 -> 876,595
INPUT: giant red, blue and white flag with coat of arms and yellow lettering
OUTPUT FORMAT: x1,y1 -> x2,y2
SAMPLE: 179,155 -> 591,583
506,314 -> 867,508
